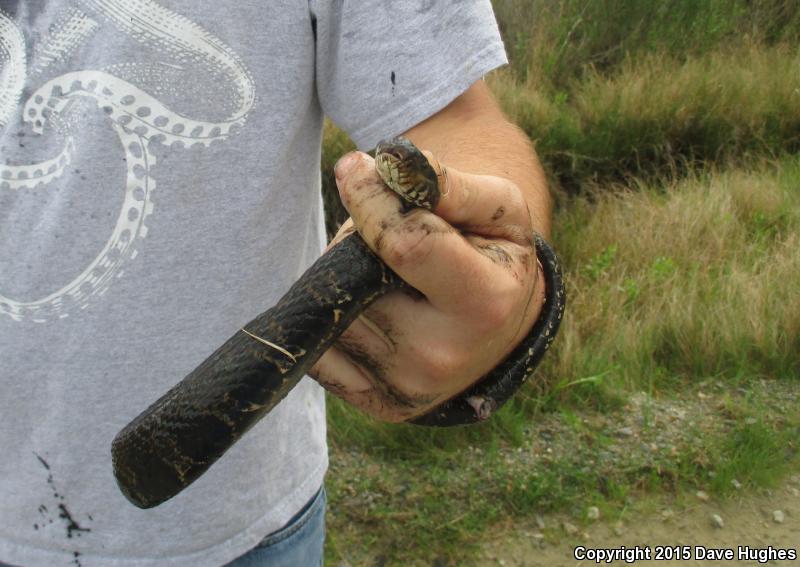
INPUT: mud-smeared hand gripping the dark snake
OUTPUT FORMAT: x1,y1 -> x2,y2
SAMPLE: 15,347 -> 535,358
311,152 -> 544,421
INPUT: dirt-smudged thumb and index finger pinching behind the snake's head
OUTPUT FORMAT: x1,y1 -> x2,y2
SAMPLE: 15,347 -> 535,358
336,152 -> 535,316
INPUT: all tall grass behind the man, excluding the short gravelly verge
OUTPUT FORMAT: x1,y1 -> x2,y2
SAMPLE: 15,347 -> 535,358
323,0 -> 800,451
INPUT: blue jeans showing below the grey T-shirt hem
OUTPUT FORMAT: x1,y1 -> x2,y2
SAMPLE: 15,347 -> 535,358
225,486 -> 326,567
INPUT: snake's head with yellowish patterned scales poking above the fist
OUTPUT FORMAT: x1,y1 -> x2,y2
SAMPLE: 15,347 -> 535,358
375,136 -> 440,210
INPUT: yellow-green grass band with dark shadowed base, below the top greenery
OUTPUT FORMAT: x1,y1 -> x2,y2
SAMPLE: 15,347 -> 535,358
489,44 -> 800,192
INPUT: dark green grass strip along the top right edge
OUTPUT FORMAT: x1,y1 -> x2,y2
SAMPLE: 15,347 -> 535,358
492,0 -> 800,87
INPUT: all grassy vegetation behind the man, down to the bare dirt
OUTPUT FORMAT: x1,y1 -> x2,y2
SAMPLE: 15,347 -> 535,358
323,0 -> 800,565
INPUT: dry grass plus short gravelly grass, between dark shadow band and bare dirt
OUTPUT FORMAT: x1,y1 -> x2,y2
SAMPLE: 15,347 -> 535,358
328,154 -> 800,565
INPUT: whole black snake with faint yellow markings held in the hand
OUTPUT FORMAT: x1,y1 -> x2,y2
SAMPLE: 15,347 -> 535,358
111,137 -> 566,508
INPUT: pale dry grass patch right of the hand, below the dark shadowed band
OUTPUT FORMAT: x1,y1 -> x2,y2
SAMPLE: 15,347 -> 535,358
547,155 -> 800,400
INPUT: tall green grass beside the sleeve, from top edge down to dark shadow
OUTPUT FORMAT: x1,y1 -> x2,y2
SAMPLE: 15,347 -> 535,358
491,0 -> 800,191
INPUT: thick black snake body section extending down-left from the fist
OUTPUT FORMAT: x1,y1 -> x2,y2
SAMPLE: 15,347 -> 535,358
111,234 -> 402,508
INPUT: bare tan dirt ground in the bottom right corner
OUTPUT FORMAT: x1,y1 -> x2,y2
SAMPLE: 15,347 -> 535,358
477,474 -> 800,567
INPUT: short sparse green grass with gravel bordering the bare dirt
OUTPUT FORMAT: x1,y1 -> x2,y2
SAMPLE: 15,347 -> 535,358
327,384 -> 800,565
